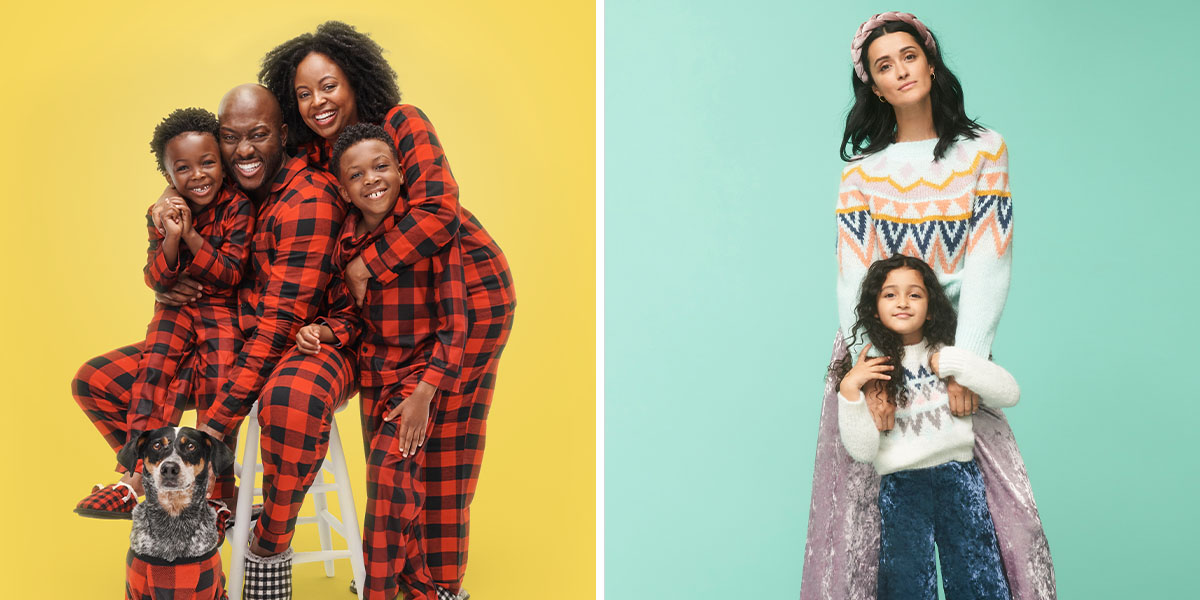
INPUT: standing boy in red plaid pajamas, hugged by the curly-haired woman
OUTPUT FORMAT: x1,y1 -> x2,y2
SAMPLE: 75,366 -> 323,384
296,124 -> 467,600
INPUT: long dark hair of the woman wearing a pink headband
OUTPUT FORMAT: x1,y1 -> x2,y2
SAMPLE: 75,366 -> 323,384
841,20 -> 983,161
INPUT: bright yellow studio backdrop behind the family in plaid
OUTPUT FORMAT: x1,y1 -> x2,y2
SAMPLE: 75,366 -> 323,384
0,0 -> 595,600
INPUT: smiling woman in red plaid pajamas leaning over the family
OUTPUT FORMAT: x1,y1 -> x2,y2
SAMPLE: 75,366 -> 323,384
259,20 -> 516,599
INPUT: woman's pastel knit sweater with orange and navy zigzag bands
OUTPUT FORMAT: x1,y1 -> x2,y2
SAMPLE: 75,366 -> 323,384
838,130 -> 1013,360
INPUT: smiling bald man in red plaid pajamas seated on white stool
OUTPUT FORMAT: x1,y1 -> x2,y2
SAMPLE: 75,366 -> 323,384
72,84 -> 355,599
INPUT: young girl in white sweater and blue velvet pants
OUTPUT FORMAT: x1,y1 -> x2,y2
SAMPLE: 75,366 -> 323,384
833,254 -> 1020,600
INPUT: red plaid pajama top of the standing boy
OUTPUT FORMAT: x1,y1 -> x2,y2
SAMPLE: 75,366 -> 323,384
335,210 -> 467,391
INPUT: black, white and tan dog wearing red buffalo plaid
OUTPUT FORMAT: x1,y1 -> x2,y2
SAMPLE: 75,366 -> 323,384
116,427 -> 233,600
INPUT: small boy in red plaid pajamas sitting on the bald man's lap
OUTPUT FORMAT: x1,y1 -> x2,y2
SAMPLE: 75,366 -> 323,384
76,108 -> 254,518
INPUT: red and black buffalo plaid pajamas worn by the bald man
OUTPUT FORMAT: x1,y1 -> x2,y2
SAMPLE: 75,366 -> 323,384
203,158 -> 354,553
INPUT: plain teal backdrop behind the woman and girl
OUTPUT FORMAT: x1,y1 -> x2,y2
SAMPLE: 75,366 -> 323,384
604,0 -> 1200,599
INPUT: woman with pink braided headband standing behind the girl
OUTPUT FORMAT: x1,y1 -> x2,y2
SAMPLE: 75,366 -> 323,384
800,12 -> 1056,600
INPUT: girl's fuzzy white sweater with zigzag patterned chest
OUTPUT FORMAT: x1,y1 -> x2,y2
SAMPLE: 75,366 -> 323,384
838,341 -> 1021,475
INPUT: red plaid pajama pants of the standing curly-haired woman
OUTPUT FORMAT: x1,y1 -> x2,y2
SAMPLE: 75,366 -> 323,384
421,248 -> 516,592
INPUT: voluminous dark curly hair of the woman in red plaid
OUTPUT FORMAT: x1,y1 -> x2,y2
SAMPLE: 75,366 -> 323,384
258,20 -> 400,149
